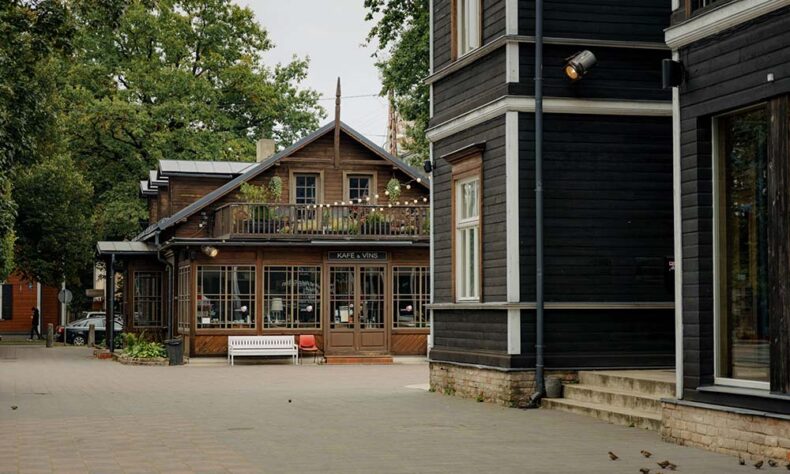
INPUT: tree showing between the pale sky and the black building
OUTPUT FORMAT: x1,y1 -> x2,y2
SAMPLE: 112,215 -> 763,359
365,0 -> 430,165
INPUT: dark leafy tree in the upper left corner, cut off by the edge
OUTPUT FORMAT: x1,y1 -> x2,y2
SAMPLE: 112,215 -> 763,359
0,0 -> 72,281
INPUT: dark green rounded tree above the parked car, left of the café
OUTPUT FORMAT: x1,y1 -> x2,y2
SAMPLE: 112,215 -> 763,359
14,155 -> 95,285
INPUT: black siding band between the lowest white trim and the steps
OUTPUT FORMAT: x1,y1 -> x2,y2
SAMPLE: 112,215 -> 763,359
513,309 -> 675,369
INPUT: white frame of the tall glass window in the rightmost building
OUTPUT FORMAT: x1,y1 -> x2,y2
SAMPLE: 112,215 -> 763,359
711,107 -> 771,391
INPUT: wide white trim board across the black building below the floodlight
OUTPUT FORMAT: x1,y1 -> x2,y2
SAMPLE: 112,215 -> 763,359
426,96 -> 672,142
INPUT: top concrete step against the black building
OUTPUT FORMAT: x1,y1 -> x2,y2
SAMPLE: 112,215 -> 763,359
579,370 -> 675,398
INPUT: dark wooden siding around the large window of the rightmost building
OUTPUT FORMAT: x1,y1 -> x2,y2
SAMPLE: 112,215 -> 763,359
680,8 -> 790,396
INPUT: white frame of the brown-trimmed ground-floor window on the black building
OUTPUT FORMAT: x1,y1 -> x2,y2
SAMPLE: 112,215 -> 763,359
454,174 -> 482,301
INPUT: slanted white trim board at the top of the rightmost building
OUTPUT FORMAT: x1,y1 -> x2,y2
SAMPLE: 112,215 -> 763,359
664,0 -> 790,49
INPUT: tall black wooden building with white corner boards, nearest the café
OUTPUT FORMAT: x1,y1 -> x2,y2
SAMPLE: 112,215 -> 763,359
427,0 -> 675,404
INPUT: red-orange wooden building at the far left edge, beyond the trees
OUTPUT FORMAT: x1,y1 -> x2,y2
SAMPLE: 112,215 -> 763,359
0,272 -> 62,335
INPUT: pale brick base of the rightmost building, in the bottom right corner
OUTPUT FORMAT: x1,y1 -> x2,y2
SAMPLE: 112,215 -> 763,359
661,402 -> 790,462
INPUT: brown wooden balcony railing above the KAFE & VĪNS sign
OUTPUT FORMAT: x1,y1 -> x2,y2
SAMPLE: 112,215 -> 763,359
213,203 -> 430,240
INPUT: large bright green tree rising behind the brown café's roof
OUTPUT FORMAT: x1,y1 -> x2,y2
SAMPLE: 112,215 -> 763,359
65,0 -> 324,238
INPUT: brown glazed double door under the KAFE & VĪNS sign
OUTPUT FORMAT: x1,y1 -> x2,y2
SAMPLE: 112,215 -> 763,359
327,265 -> 387,353
